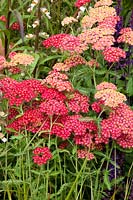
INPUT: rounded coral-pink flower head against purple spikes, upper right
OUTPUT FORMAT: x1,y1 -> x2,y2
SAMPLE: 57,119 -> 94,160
102,47 -> 126,62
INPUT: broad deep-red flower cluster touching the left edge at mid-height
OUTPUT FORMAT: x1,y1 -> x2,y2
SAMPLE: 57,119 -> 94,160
0,78 -> 43,106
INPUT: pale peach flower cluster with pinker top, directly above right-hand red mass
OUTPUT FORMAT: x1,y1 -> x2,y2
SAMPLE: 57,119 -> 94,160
95,82 -> 127,108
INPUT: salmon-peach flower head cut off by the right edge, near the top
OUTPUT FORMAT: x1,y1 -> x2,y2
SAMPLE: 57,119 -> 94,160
117,28 -> 133,45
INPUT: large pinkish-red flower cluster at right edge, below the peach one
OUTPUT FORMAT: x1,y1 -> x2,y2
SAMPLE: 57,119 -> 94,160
101,103 -> 133,148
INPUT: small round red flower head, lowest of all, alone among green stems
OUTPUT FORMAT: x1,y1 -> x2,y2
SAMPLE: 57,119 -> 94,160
33,147 -> 52,165
